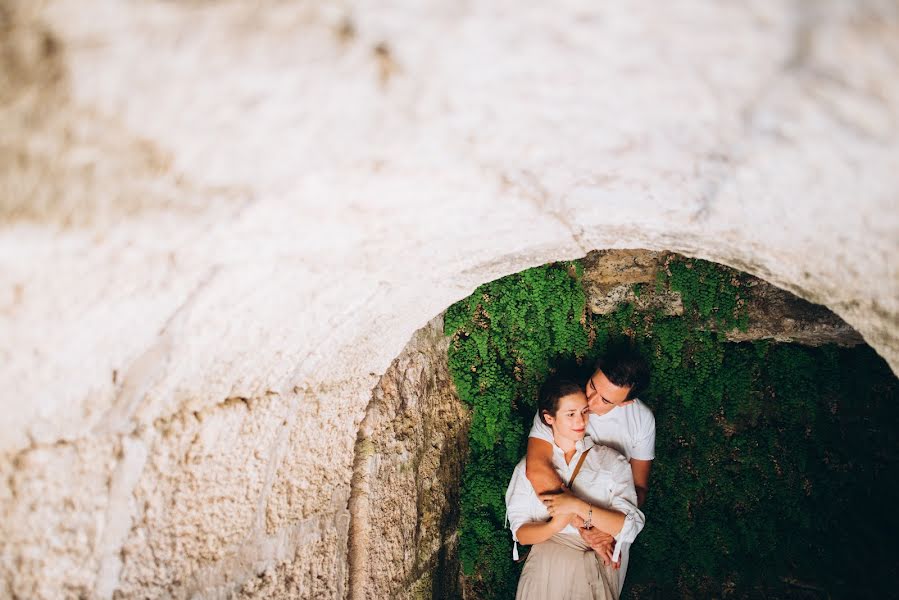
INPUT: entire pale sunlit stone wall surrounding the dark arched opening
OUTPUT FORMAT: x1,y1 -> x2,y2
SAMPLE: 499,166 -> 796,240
0,0 -> 899,598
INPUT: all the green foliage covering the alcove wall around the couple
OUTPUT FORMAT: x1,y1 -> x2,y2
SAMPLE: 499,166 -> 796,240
446,258 -> 899,598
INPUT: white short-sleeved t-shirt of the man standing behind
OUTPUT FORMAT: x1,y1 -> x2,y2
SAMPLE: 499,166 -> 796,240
528,399 -> 656,460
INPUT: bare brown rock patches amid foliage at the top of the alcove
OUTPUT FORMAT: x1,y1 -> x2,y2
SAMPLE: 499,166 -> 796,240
584,250 -> 864,346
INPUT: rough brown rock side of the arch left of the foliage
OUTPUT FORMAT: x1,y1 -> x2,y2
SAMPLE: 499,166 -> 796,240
349,317 -> 469,600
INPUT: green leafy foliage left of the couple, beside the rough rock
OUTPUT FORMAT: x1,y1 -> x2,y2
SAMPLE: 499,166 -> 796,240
446,263 -> 590,598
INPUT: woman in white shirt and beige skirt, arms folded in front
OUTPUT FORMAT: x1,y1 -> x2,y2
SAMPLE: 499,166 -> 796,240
506,378 -> 643,600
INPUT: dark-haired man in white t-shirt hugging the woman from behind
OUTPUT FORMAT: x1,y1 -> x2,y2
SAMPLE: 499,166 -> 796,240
526,349 -> 656,581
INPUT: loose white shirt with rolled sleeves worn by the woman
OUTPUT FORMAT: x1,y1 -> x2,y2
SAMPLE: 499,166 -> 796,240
506,437 -> 644,561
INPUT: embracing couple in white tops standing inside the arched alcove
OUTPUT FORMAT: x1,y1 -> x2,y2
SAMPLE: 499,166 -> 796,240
506,350 -> 655,600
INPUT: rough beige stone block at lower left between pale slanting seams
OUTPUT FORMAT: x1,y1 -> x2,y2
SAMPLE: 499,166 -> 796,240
115,396 -> 290,597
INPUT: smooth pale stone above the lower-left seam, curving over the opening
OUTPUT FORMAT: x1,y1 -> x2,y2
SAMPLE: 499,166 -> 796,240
0,1 -> 899,450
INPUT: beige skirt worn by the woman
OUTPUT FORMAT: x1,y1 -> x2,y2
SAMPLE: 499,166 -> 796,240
515,533 -> 618,600
